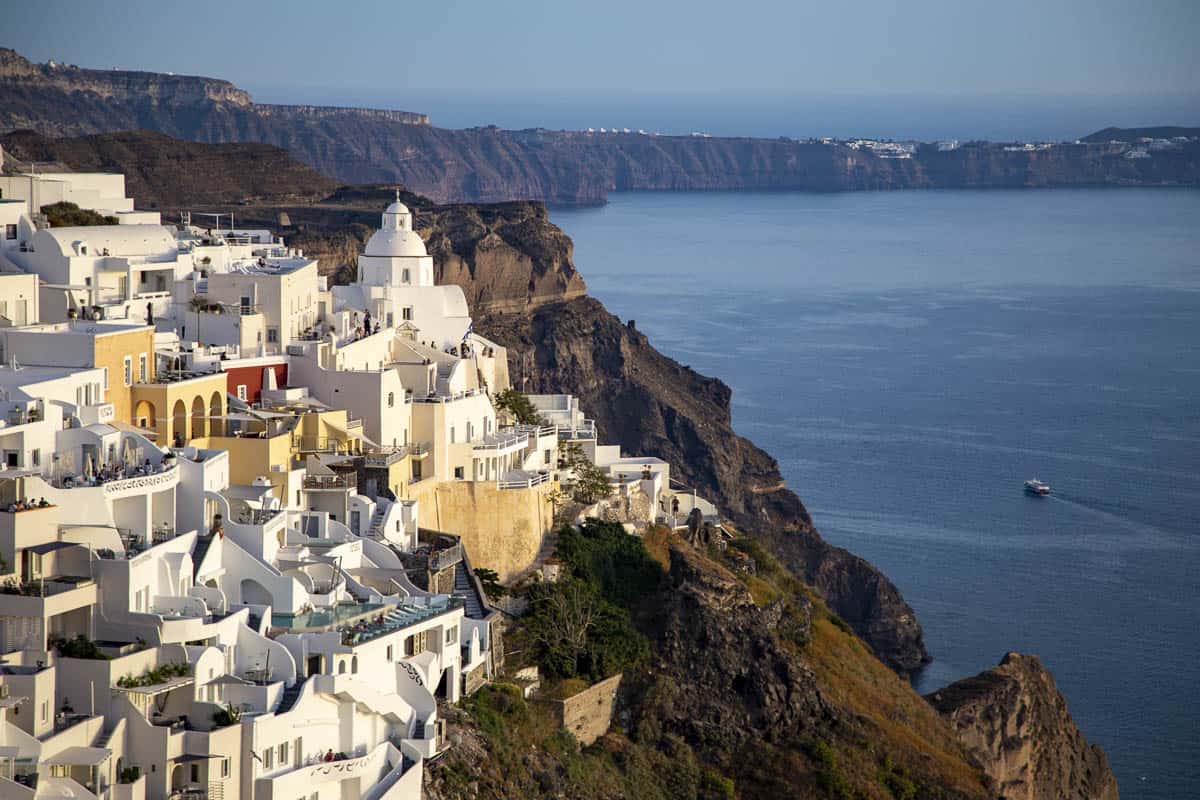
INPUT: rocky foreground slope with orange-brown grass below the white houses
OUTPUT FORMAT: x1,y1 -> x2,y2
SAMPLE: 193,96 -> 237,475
425,537 -> 988,800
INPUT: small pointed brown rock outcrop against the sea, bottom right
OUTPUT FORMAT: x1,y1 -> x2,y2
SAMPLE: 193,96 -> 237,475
926,652 -> 1118,800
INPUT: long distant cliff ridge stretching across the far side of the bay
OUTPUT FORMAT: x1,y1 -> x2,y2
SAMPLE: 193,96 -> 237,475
0,49 -> 1200,203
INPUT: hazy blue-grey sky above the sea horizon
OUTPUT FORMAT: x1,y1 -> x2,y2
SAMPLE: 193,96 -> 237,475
9,0 -> 1200,100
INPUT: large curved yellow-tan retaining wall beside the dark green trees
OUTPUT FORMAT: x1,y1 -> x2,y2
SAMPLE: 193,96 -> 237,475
413,481 -> 553,581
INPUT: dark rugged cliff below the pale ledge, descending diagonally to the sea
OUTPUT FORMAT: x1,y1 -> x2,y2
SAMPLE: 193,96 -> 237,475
478,296 -> 928,672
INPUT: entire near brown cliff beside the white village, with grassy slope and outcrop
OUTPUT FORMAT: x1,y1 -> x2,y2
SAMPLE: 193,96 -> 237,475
9,134 -> 1116,800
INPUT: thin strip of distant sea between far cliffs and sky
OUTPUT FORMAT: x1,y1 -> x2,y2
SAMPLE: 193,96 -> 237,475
245,83 -> 1200,142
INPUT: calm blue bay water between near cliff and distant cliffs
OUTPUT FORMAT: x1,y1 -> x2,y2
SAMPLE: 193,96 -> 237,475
552,190 -> 1200,799
